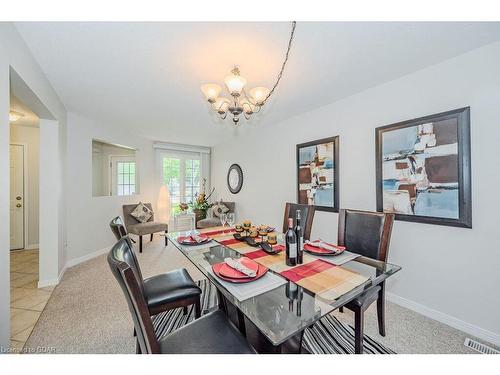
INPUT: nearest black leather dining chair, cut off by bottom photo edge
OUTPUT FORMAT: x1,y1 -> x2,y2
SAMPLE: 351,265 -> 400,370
108,238 -> 255,354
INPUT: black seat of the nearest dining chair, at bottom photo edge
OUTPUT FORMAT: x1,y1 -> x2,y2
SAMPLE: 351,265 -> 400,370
160,310 -> 255,354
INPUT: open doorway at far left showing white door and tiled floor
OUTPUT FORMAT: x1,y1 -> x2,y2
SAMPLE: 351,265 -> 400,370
9,95 -> 52,352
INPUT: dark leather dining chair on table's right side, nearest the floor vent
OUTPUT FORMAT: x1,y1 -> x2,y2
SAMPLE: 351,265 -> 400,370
337,209 -> 394,354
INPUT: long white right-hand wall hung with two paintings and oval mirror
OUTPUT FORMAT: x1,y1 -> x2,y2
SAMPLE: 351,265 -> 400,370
212,43 -> 500,344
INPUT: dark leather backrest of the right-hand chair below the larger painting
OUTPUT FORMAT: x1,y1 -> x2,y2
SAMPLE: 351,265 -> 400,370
337,209 -> 394,261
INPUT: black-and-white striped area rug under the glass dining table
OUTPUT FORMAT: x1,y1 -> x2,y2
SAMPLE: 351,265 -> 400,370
153,280 -> 394,354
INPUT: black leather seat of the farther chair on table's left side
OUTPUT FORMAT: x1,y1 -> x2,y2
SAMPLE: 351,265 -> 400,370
144,268 -> 201,308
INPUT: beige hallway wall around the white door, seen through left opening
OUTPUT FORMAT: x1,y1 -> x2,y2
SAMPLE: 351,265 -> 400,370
10,124 -> 40,248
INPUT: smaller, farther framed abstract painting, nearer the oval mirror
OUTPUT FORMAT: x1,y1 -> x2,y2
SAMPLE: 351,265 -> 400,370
297,136 -> 339,212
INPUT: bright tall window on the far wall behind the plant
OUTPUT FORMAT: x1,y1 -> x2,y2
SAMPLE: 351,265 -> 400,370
162,155 -> 201,213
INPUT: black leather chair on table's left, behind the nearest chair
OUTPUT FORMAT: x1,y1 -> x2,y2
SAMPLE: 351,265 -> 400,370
110,222 -> 201,318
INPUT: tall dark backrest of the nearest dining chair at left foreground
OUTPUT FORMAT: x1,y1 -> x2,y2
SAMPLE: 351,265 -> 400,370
108,237 -> 160,354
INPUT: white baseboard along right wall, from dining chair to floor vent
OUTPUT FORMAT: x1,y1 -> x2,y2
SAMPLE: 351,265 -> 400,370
386,292 -> 500,346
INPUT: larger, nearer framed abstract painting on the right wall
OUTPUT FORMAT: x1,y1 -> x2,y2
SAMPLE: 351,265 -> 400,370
375,107 -> 472,228
